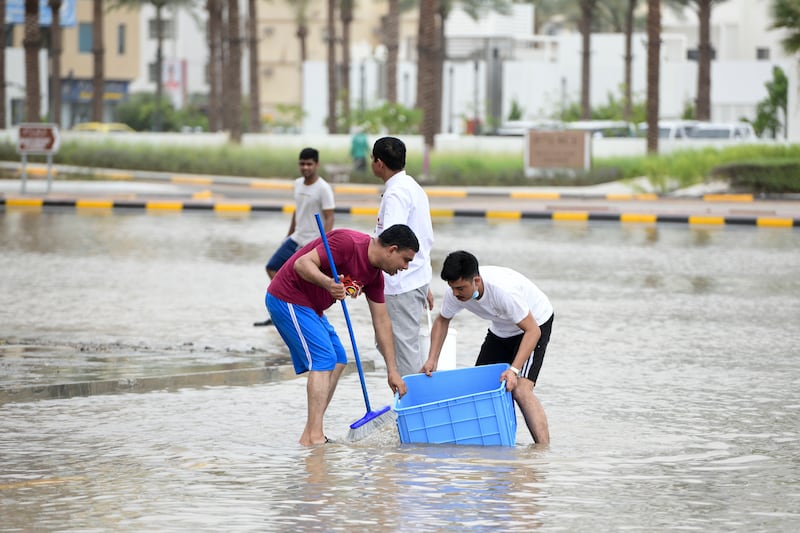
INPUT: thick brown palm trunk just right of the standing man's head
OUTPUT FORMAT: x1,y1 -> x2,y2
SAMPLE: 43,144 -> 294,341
416,0 -> 440,150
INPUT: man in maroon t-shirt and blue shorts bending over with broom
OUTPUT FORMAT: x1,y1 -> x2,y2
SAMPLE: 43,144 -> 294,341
265,224 -> 419,446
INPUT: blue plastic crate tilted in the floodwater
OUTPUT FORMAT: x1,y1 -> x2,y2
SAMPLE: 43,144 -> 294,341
393,364 -> 517,446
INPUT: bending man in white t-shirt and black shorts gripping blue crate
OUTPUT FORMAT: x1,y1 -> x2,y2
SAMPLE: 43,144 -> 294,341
423,250 -> 553,444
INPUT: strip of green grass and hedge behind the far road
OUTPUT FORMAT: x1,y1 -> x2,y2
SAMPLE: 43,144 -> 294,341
0,140 -> 800,193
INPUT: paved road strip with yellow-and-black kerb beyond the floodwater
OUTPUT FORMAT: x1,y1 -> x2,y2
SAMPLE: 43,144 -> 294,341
0,164 -> 800,227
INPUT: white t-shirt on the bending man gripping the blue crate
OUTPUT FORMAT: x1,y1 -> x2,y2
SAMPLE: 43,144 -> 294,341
441,266 -> 553,339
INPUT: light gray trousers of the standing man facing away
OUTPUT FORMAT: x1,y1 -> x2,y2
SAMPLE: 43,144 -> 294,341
386,285 -> 428,376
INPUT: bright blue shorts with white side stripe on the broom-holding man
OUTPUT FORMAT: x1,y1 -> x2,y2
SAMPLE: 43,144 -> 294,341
265,293 -> 347,374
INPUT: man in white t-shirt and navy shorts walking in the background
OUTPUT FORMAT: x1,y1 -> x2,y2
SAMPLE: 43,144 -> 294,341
253,148 -> 336,326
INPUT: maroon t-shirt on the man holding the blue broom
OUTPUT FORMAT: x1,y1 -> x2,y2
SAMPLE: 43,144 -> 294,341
267,229 -> 385,315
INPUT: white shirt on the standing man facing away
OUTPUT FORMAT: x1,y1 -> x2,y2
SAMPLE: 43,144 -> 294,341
375,170 -> 433,294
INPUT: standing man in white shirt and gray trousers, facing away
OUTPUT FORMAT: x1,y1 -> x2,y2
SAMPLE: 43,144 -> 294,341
371,137 -> 433,376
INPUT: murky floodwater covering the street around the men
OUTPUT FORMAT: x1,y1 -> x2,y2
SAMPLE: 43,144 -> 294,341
0,210 -> 800,533
